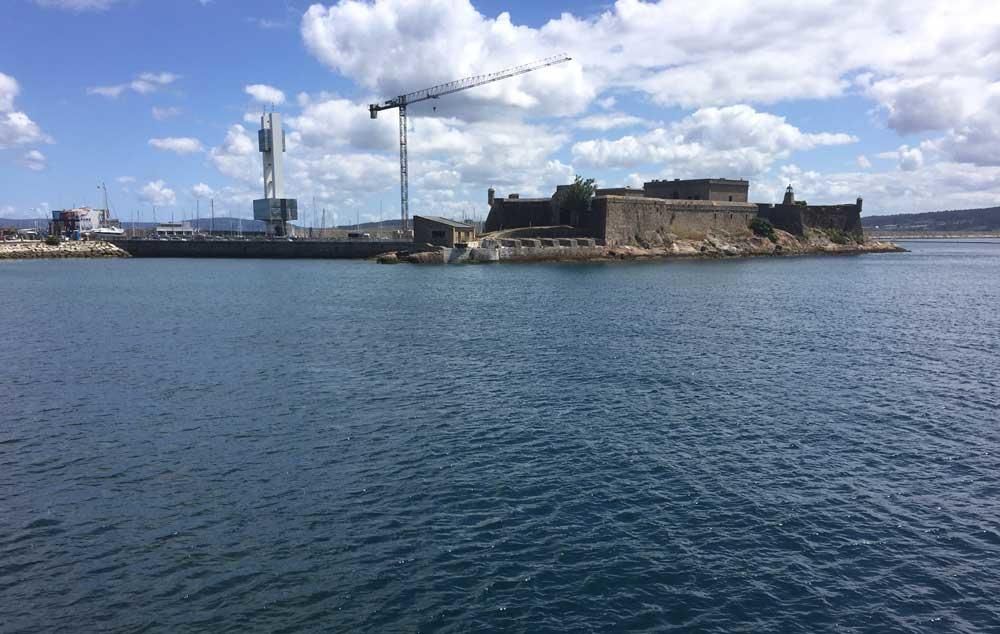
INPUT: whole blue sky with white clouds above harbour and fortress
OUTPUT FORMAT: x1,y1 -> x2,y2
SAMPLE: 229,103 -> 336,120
0,0 -> 1000,223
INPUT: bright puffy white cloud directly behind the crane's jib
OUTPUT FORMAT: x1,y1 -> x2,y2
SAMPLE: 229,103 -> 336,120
301,0 -> 595,116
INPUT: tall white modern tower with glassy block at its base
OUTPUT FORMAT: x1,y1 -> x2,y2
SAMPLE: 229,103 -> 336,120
253,112 -> 299,238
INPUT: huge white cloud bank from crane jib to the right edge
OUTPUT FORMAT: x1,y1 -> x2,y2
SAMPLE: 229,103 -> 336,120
301,0 -> 1000,174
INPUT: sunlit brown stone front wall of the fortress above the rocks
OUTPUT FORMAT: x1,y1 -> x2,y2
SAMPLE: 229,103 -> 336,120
589,196 -> 757,246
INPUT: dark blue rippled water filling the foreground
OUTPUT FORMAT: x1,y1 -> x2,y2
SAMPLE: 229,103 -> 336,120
0,243 -> 1000,632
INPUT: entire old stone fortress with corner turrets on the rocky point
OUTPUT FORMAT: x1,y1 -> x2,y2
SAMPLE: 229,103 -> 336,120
484,178 -> 864,248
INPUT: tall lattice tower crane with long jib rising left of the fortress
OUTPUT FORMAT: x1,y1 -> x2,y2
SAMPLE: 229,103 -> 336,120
368,55 -> 573,231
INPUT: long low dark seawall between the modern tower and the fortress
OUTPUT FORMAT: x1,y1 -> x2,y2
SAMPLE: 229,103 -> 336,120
115,240 -> 434,259
